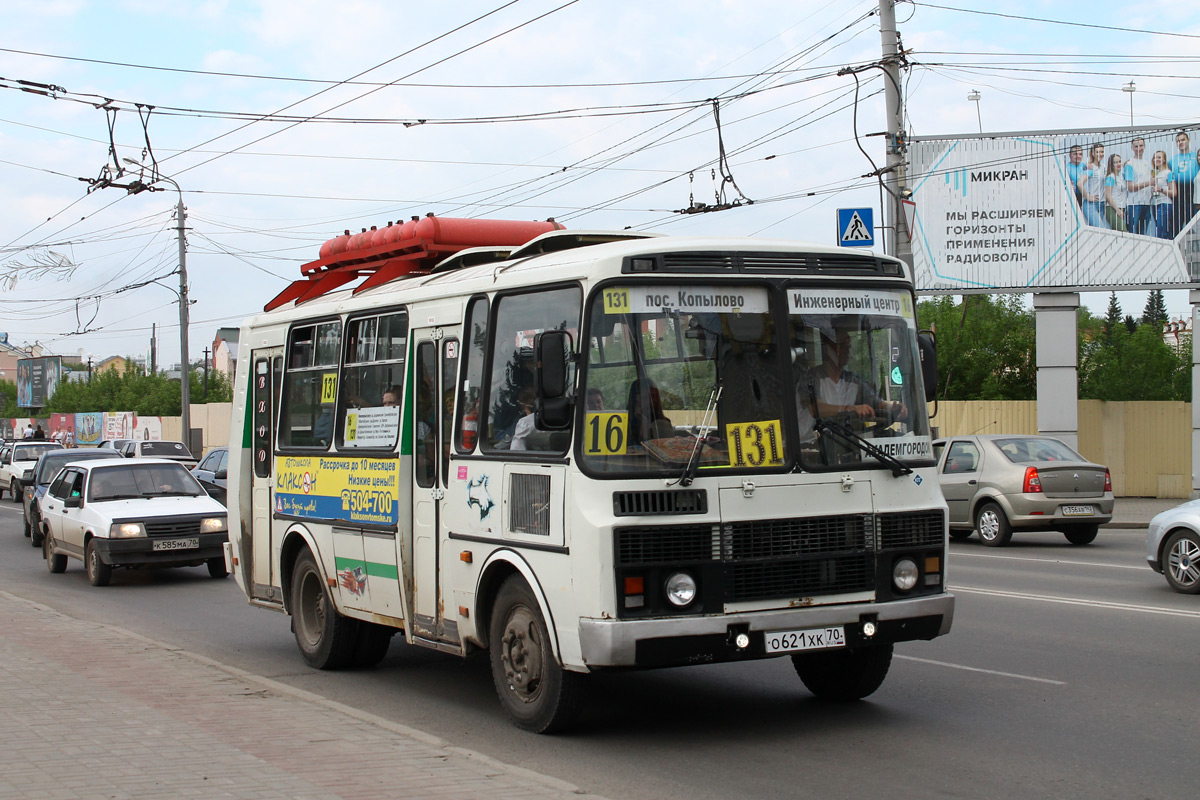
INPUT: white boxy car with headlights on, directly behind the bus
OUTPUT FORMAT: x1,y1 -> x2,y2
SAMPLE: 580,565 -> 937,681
40,458 -> 229,587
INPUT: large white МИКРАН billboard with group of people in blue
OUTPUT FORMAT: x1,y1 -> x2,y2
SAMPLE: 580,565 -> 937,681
910,128 -> 1200,293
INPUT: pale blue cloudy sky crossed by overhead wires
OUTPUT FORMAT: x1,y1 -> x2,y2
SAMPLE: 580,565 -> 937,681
0,0 -> 1200,363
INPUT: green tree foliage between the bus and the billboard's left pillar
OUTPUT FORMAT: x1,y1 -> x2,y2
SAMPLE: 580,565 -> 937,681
917,295 -> 1037,399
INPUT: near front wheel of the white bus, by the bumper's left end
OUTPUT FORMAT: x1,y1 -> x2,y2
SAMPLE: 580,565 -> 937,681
488,576 -> 582,733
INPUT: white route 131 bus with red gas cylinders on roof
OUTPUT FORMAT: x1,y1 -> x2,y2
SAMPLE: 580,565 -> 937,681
227,221 -> 954,732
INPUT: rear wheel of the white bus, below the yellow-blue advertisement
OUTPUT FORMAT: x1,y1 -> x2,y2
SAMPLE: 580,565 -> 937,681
292,549 -> 358,669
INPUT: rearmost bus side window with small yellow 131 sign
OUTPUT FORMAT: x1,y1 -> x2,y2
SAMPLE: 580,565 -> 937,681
280,320 -> 342,450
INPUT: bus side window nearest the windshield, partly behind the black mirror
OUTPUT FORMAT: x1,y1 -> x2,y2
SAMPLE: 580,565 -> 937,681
481,287 -> 583,452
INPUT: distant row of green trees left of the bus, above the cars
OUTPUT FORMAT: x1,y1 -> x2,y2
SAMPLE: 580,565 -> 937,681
42,360 -> 233,416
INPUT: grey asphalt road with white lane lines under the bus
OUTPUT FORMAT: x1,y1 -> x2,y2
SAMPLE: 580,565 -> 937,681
0,498 -> 1200,800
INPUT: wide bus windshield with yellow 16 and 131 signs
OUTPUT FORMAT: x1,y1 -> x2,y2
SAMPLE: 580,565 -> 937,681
580,283 -> 931,477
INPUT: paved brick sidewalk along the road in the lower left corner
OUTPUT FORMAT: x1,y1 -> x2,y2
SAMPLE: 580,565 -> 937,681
0,591 -> 604,800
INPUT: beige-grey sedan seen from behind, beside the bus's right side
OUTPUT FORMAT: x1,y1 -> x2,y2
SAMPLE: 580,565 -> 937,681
934,434 -> 1114,547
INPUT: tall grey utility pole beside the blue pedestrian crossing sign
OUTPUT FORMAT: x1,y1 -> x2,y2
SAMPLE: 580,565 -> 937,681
880,0 -> 912,269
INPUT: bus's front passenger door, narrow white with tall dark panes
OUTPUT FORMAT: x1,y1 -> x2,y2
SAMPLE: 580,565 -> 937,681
408,325 -> 460,643
